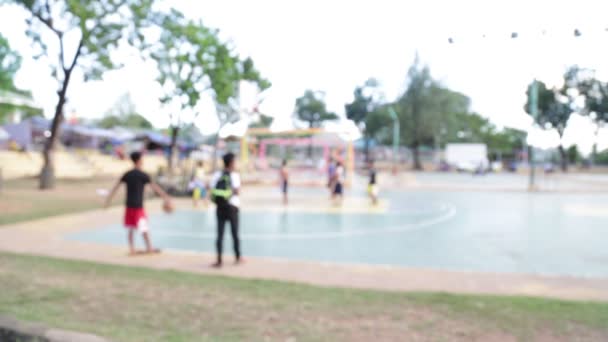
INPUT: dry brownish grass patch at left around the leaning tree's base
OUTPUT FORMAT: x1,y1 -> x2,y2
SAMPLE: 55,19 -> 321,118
0,178 -> 124,225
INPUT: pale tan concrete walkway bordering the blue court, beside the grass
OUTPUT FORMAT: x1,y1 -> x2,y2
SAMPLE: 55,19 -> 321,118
0,198 -> 608,301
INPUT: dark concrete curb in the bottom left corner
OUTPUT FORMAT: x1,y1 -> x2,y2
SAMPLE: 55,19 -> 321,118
0,316 -> 110,342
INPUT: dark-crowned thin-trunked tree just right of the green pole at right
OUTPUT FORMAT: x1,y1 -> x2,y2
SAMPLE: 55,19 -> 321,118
524,81 -> 573,171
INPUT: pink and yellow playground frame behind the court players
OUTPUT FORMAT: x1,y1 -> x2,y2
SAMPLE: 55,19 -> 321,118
240,128 -> 355,185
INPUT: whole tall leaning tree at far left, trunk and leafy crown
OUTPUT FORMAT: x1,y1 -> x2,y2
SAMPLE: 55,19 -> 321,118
8,0 -> 153,189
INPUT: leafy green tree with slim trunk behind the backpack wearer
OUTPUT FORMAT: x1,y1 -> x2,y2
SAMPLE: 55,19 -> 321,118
151,10 -> 270,172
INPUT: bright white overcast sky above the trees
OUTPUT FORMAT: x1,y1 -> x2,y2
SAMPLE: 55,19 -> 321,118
0,0 -> 608,151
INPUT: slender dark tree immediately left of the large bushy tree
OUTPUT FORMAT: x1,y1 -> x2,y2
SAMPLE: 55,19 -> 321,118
344,78 -> 379,161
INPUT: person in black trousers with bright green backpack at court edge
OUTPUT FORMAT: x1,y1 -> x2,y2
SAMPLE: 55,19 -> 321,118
211,153 -> 243,268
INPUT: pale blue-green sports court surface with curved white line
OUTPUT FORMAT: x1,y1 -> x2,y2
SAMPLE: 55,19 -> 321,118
69,189 -> 608,277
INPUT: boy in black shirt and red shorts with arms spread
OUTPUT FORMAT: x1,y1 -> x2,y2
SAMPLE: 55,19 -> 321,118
105,152 -> 172,255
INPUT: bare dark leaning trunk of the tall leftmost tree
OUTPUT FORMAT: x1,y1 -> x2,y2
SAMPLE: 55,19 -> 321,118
39,70 -> 72,190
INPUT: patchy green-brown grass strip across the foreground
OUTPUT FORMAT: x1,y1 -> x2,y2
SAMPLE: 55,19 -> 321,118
0,253 -> 608,341
